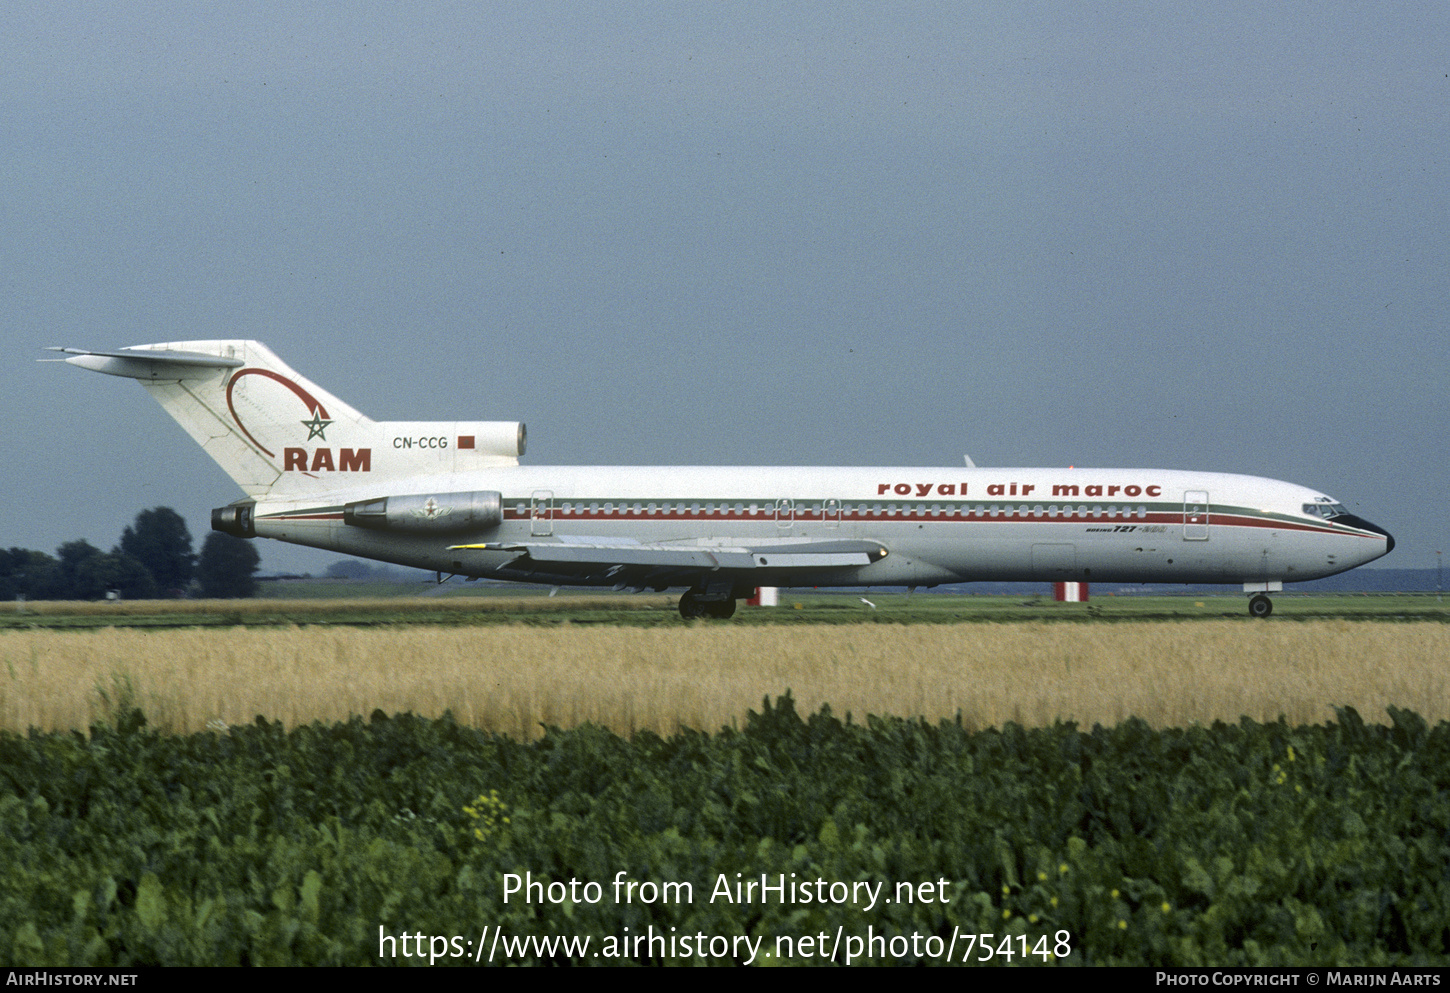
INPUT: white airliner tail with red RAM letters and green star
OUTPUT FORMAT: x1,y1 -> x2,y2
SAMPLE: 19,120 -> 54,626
52,341 -> 525,499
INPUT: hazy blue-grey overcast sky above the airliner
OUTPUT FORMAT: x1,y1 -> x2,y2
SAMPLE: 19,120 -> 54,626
0,0 -> 1450,571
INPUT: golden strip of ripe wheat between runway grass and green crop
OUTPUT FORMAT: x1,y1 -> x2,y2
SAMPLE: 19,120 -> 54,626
0,620 -> 1450,738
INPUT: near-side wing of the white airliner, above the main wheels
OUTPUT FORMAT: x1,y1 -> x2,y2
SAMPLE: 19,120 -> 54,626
451,538 -> 886,586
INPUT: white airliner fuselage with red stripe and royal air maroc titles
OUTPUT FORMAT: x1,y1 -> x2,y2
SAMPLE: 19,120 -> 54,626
255,465 -> 1389,586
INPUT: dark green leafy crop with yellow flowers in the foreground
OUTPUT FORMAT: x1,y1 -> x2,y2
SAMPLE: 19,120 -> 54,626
0,695 -> 1450,965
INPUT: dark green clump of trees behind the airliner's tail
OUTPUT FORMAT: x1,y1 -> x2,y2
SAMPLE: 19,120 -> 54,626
0,507 -> 261,600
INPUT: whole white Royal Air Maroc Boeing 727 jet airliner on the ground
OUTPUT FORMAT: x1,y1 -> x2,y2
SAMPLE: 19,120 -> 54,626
55,341 -> 1395,618
